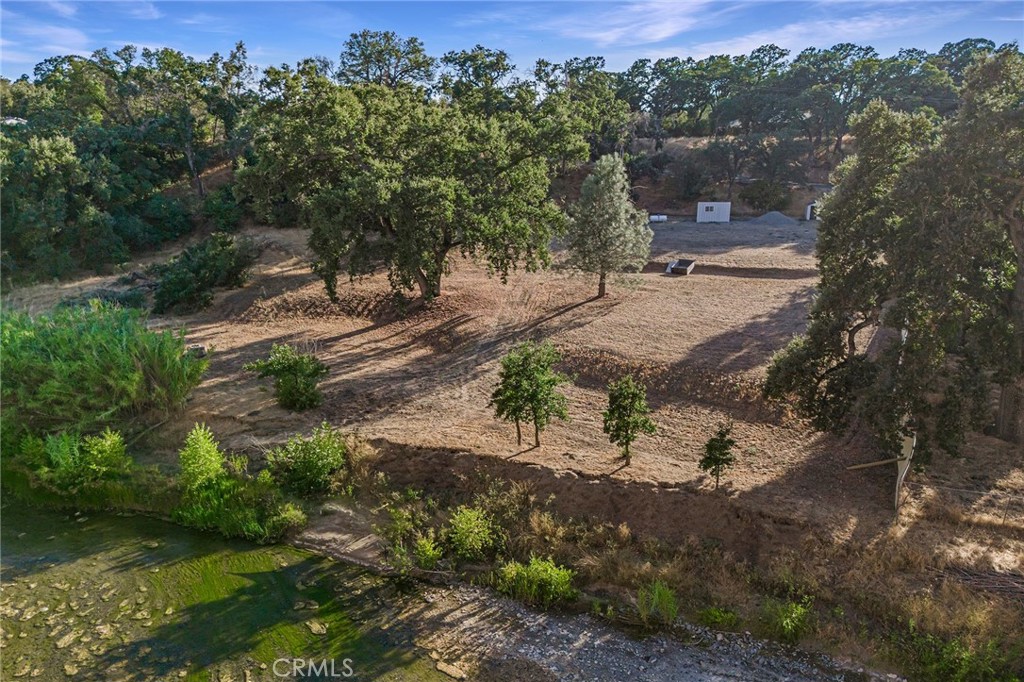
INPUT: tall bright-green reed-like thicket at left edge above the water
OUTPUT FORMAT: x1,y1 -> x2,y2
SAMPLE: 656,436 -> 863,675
0,302 -> 207,452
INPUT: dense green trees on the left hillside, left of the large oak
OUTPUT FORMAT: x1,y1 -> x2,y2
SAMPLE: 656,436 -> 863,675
0,43 -> 254,278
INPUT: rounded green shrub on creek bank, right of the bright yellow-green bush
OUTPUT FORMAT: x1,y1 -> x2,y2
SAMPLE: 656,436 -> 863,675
266,422 -> 348,495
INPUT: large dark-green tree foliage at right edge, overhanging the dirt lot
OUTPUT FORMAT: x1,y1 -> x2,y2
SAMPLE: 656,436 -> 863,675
767,49 -> 1024,451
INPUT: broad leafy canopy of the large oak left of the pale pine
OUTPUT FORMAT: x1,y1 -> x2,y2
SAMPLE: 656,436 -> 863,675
239,59 -> 580,299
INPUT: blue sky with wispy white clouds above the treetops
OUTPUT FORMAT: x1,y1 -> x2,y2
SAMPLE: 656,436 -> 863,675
0,0 -> 1024,78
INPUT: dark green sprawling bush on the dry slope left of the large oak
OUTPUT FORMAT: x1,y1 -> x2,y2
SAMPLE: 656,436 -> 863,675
153,232 -> 259,313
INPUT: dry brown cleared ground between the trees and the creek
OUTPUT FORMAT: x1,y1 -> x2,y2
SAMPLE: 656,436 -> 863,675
7,210 -> 1024,655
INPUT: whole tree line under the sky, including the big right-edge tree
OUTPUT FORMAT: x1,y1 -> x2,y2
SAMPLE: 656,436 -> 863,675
0,31 -> 1024,446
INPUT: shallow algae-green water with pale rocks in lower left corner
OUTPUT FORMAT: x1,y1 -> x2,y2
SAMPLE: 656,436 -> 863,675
0,504 -> 446,682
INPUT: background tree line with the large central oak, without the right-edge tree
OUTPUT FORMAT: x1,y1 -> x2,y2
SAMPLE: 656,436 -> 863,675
0,31 -> 1016,280
